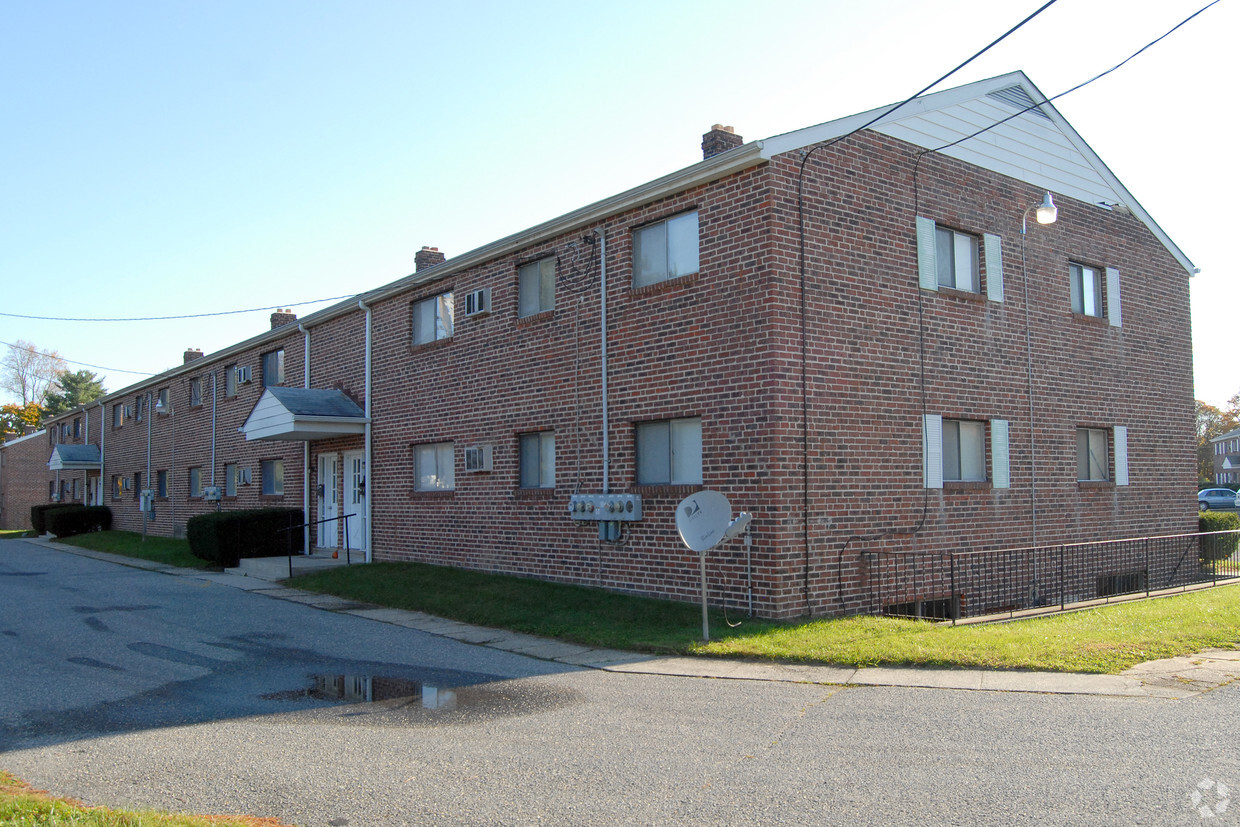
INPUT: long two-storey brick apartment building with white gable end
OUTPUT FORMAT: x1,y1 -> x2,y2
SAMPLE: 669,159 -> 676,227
4,73 -> 1195,617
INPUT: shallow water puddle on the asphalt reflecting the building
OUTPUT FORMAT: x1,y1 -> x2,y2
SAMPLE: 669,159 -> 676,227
259,674 -> 577,722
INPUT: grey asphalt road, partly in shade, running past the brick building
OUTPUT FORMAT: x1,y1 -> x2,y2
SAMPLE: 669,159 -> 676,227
0,541 -> 1240,827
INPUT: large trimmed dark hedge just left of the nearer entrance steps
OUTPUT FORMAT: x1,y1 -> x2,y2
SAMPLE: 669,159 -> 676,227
185,508 -> 305,568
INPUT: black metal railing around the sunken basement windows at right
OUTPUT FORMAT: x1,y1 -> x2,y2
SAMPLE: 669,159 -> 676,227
862,531 -> 1240,621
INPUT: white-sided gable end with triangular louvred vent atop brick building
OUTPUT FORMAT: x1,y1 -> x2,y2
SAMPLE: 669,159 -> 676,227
759,72 -> 1197,274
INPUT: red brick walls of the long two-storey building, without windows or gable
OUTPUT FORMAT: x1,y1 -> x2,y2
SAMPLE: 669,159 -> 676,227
21,133 -> 1195,617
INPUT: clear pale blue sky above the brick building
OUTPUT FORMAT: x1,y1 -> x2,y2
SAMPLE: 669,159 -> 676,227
0,0 -> 1240,404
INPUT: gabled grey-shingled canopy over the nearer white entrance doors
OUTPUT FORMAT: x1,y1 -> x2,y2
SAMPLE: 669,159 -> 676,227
241,387 -> 370,443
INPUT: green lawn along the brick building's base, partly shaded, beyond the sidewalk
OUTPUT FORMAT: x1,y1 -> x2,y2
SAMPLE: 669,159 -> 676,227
50,532 -> 1240,673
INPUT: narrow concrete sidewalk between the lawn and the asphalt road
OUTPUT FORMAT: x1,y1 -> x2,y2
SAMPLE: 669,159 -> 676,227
25,538 -> 1240,699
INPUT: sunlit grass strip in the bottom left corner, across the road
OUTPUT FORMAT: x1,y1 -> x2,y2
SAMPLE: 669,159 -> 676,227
0,770 -> 292,827
